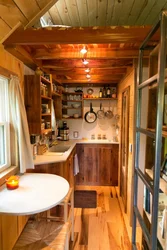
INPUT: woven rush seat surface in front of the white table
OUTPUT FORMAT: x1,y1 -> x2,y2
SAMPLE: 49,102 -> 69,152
13,220 -> 69,250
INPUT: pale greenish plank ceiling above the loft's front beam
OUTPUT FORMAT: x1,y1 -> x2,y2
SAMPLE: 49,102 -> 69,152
45,0 -> 167,27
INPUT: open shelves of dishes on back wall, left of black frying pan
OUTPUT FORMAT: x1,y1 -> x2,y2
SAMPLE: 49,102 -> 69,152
62,92 -> 83,119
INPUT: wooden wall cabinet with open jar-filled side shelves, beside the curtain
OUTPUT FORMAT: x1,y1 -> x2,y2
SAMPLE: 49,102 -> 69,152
24,75 -> 51,134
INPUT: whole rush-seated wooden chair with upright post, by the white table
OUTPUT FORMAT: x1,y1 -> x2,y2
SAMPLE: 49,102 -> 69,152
13,188 -> 74,250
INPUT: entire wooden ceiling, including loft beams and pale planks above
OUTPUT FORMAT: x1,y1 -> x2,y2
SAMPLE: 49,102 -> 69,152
0,0 -> 167,85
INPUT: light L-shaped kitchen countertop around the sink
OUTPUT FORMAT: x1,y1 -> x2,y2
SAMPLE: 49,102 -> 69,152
34,139 -> 119,165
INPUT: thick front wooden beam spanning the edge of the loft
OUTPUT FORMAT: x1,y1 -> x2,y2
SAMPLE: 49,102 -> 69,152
5,26 -> 159,45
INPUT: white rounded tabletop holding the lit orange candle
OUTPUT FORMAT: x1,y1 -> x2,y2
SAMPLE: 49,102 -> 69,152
0,173 -> 69,215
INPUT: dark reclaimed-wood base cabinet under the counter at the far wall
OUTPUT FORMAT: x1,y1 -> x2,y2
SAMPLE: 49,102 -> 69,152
76,144 -> 118,186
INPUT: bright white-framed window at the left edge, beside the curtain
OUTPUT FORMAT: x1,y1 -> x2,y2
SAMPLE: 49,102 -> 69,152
0,76 -> 11,172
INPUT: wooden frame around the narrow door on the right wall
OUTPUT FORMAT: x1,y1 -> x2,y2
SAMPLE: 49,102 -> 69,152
119,86 -> 130,213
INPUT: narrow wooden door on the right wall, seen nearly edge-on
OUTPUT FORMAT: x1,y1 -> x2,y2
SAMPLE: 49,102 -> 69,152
120,87 -> 130,213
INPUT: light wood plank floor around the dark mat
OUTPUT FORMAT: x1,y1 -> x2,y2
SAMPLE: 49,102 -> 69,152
70,186 -> 131,250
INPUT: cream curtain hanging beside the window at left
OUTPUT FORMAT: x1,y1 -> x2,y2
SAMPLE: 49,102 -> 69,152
9,76 -> 34,173
